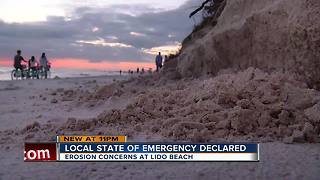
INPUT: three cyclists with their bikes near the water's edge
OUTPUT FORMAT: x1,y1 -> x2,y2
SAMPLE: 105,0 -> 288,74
14,50 -> 50,79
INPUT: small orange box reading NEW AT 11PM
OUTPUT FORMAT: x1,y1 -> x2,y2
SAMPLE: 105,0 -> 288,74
57,136 -> 127,143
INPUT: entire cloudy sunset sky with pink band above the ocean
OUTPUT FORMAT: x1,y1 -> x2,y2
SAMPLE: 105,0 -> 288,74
0,0 -> 201,70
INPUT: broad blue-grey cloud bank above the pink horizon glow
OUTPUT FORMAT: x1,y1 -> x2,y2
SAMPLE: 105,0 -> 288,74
0,0 -> 199,62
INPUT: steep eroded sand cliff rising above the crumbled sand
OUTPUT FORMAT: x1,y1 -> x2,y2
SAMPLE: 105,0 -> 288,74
177,0 -> 320,88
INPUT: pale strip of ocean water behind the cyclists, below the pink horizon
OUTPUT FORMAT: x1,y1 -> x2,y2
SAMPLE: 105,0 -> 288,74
0,67 -> 119,81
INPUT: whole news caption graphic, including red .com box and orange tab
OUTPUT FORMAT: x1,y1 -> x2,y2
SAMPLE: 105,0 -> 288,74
24,136 -> 259,162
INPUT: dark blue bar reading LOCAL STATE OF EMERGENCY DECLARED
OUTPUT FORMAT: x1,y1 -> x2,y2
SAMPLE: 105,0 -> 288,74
59,143 -> 258,153
